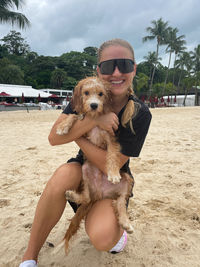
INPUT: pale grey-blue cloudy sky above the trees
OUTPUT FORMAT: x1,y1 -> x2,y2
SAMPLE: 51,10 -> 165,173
0,0 -> 200,64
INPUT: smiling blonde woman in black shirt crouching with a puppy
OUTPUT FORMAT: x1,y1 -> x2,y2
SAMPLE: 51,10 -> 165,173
20,39 -> 151,267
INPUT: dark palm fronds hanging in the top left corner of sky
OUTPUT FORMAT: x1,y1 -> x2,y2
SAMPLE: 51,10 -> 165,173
0,0 -> 30,29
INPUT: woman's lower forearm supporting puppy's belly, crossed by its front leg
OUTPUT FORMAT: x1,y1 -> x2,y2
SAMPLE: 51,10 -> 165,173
76,137 -> 129,174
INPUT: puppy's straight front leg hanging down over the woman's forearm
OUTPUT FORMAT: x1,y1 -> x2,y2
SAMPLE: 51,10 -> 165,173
106,134 -> 121,184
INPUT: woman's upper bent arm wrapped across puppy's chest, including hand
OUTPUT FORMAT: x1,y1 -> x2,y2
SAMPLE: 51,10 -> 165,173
48,112 -> 118,146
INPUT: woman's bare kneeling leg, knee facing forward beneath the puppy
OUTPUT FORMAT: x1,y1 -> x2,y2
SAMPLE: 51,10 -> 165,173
85,199 -> 124,251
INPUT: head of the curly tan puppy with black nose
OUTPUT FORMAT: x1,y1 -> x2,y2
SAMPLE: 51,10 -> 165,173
72,77 -> 110,117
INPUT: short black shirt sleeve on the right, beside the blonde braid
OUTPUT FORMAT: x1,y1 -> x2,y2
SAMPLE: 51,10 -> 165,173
118,104 -> 152,157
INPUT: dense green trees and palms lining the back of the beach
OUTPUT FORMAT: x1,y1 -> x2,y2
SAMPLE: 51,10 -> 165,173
0,25 -> 200,97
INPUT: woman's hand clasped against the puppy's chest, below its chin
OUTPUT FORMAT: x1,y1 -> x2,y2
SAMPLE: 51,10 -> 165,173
96,112 -> 119,135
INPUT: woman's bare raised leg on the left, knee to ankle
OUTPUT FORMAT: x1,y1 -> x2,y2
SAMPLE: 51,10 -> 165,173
23,163 -> 82,261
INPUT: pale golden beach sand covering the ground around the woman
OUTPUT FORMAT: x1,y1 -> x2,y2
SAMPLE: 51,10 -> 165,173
0,107 -> 200,267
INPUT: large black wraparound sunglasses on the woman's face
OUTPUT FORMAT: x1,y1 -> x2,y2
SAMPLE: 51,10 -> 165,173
98,58 -> 134,75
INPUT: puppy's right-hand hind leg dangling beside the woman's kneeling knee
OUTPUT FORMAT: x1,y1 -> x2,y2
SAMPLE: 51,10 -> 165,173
112,196 -> 133,234
